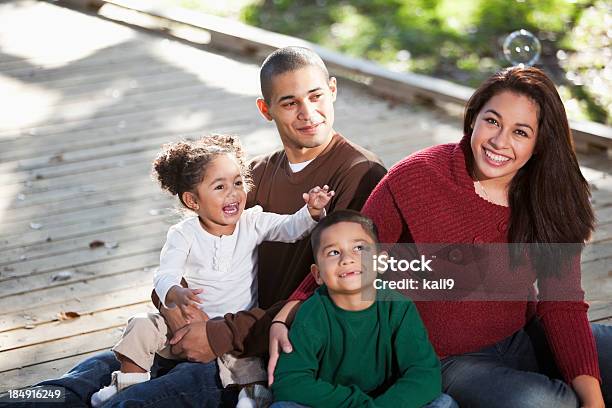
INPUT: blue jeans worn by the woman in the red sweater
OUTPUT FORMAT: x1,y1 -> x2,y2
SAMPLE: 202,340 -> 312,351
442,320 -> 612,408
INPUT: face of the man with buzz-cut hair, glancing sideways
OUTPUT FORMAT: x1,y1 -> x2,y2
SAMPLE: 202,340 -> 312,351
257,65 -> 336,158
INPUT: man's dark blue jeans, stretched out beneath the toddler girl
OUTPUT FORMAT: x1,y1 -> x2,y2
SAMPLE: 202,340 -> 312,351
4,351 -> 238,408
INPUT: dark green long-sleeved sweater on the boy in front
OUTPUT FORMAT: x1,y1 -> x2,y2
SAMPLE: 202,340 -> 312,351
272,286 -> 441,408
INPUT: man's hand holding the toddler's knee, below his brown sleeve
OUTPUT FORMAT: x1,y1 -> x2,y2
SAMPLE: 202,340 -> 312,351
170,321 -> 216,363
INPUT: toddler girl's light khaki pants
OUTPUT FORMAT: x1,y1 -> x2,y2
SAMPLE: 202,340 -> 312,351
113,313 -> 267,387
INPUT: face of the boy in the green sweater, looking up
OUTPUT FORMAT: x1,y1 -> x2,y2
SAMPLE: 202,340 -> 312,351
311,222 -> 376,294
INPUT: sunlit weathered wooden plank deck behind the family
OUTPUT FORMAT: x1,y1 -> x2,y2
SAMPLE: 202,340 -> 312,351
0,0 -> 612,392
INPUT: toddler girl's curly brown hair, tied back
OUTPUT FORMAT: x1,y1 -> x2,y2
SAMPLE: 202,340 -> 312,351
153,135 -> 253,207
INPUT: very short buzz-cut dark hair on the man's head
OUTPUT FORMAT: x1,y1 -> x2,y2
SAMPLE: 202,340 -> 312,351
259,46 -> 329,104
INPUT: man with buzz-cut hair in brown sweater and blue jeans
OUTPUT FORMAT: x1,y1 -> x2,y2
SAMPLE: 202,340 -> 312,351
20,47 -> 386,406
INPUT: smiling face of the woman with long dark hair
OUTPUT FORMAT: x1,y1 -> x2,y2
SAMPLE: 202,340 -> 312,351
470,91 -> 539,184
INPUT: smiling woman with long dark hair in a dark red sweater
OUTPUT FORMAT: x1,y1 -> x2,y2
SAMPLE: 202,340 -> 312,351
278,67 -> 612,407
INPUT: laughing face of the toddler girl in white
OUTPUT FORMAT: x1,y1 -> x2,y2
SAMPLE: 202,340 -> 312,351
187,154 -> 247,236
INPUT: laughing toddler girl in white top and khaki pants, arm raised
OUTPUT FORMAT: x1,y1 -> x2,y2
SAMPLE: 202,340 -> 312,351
91,136 -> 334,406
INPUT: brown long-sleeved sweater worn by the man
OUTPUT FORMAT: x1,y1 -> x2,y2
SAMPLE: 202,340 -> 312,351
206,134 -> 386,356
